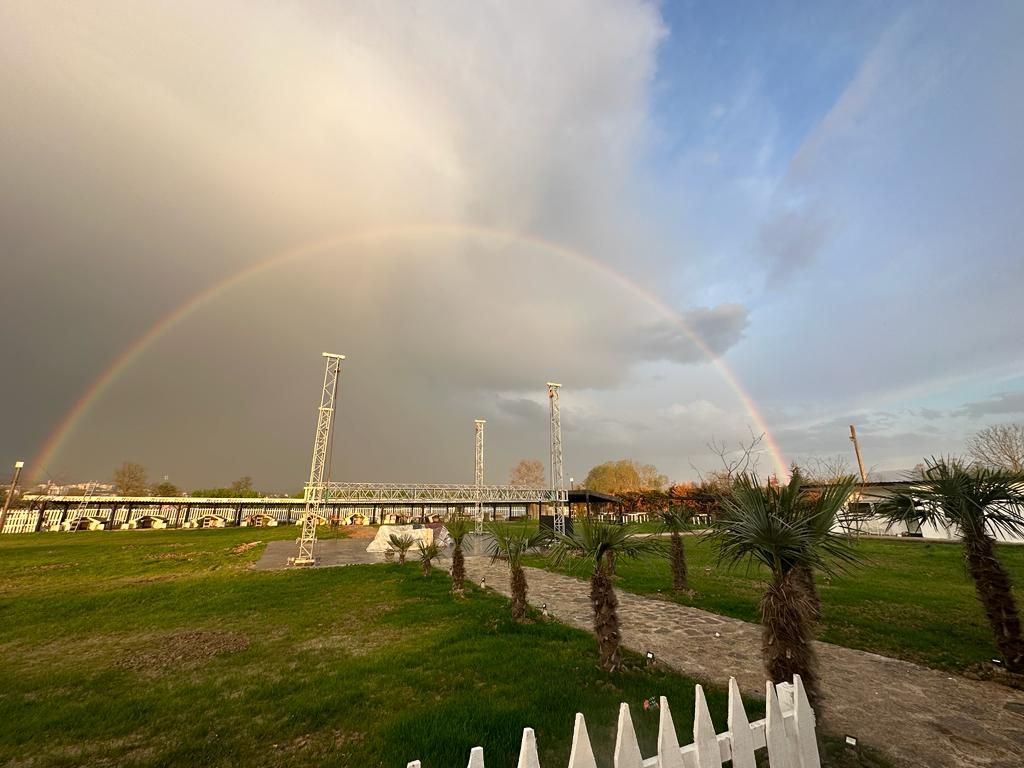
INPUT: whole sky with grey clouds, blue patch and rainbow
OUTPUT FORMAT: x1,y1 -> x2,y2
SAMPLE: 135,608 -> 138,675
0,0 -> 1024,492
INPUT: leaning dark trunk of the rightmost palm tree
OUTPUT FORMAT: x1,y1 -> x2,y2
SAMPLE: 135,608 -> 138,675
964,534 -> 1024,672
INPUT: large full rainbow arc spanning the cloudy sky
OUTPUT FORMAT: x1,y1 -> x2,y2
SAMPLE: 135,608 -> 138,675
32,225 -> 787,482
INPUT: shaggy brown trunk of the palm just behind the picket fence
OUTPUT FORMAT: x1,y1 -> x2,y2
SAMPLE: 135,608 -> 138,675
761,570 -> 820,707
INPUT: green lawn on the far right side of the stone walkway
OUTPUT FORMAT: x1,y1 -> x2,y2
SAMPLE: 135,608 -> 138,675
531,537 -> 1024,672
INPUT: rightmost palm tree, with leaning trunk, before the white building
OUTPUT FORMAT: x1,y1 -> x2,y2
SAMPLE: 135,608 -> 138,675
876,458 -> 1024,673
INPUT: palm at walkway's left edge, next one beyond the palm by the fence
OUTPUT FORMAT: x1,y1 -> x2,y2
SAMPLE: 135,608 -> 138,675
551,520 -> 665,672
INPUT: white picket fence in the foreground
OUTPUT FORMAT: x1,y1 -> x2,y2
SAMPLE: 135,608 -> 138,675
408,675 -> 821,768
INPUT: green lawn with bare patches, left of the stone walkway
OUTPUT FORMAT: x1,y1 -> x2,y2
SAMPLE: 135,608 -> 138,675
0,527 -> 774,767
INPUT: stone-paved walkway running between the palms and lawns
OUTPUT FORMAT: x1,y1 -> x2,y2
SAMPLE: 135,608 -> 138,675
467,557 -> 1024,768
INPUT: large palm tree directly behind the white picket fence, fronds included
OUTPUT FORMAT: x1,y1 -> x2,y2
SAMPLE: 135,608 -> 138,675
709,474 -> 858,702
